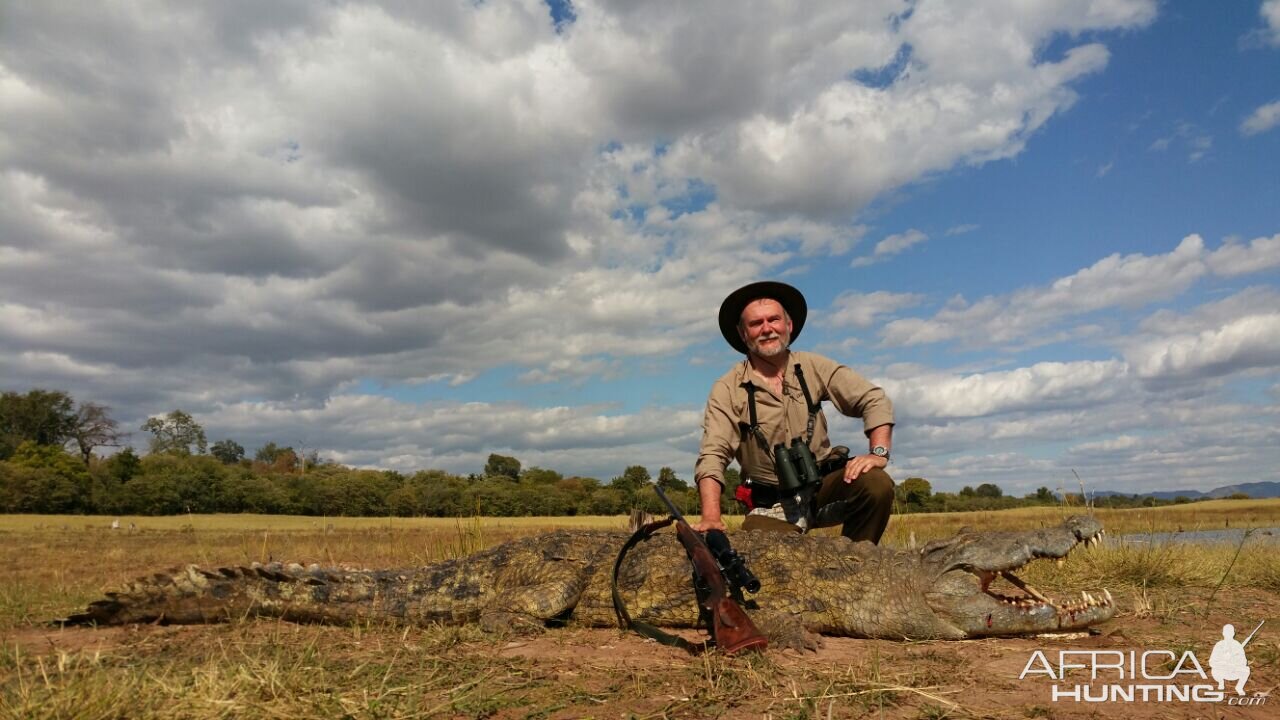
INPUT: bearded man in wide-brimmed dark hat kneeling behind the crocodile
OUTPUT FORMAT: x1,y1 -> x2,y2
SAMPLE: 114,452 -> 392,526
694,282 -> 893,543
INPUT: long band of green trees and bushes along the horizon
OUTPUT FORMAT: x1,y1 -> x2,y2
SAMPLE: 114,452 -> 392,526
0,389 -> 1218,518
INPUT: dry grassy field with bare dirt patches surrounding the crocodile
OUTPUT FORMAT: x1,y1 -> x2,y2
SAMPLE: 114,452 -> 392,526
0,501 -> 1280,717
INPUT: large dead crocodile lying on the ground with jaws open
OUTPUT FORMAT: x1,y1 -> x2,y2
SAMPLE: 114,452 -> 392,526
59,516 -> 1116,640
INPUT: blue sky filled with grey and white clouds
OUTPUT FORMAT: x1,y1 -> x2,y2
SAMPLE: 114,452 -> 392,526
0,0 -> 1280,493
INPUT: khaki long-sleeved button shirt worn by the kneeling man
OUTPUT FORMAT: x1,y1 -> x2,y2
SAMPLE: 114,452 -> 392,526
694,351 -> 893,484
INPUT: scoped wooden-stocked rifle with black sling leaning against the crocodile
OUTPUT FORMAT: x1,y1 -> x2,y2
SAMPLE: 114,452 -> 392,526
613,486 -> 769,655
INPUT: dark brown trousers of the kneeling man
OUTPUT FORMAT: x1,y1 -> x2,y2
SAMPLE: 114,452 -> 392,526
742,469 -> 893,543
